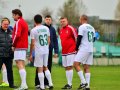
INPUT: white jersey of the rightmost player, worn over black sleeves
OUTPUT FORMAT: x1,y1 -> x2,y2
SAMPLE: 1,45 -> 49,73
78,24 -> 95,52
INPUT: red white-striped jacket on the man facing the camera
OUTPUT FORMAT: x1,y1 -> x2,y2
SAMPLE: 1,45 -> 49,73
60,25 -> 77,55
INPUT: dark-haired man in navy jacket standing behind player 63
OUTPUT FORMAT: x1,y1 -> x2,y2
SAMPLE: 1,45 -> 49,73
35,15 -> 58,88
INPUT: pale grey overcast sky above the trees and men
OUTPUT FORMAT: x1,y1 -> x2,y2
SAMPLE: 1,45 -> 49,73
0,0 -> 118,19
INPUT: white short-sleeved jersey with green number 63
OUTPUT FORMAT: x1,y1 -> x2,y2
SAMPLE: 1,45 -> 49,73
31,25 -> 50,54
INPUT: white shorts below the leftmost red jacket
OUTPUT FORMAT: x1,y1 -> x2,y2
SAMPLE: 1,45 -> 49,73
14,50 -> 26,60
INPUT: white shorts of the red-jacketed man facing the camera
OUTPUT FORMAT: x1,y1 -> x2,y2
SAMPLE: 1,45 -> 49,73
62,54 -> 75,67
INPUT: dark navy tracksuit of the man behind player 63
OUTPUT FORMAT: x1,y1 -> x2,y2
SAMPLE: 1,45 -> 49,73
35,24 -> 58,86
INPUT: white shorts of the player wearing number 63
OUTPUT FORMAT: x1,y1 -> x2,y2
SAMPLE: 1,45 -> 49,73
34,54 -> 48,67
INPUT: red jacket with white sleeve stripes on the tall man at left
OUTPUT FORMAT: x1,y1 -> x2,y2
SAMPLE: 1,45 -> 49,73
12,17 -> 28,49
